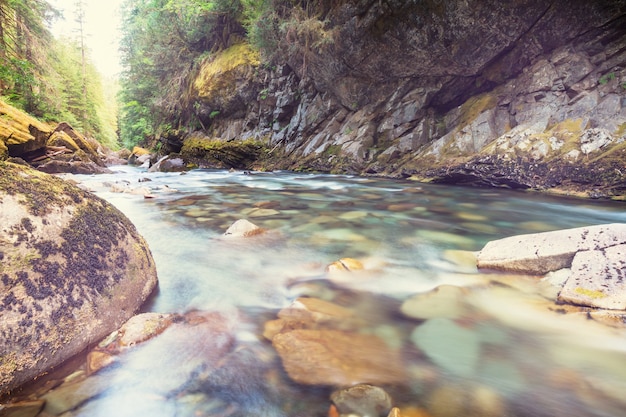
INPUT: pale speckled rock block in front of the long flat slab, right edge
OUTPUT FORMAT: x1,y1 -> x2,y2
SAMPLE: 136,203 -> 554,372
559,244 -> 626,310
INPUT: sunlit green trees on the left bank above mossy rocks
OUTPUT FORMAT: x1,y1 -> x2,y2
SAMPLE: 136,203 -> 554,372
0,0 -> 117,148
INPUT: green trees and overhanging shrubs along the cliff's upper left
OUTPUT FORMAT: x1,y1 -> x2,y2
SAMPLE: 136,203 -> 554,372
119,0 -> 337,147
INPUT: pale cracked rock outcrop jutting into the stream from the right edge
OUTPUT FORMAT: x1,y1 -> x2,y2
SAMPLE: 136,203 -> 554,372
477,224 -> 626,310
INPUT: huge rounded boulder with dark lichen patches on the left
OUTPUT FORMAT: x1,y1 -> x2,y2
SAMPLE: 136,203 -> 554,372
0,162 -> 157,393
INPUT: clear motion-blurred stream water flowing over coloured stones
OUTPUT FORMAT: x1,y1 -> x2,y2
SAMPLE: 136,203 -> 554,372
36,167 -> 626,417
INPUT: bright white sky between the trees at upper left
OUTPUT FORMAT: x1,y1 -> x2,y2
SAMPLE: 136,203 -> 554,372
48,0 -> 122,77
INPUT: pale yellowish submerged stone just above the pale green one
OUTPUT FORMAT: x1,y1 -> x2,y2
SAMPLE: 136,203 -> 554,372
400,285 -> 465,320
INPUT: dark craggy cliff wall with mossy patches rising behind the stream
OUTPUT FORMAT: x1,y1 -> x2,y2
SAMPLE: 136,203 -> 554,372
172,0 -> 626,196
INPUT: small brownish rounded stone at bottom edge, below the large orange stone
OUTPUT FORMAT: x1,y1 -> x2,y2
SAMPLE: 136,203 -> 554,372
330,384 -> 392,417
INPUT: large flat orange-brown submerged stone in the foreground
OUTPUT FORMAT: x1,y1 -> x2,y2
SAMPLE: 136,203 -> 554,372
272,330 -> 406,386
